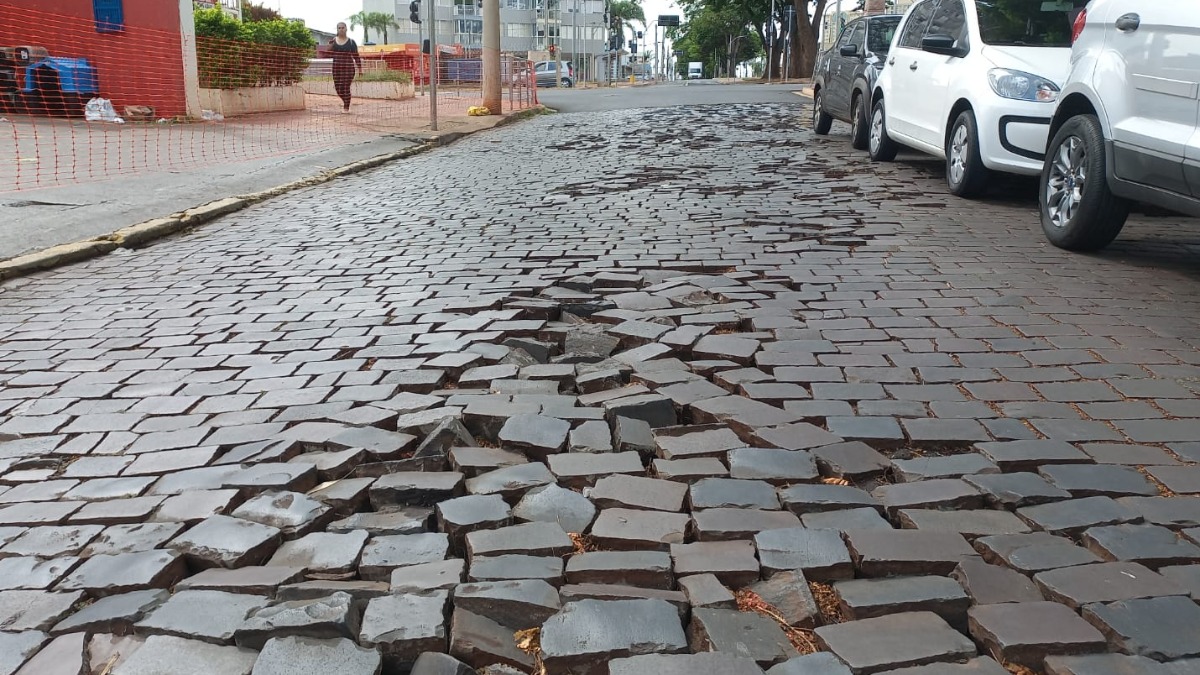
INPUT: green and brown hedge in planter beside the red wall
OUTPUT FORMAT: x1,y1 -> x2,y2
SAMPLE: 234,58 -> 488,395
194,8 -> 314,89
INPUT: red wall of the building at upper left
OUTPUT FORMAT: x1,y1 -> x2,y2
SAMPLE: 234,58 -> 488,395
0,0 -> 186,117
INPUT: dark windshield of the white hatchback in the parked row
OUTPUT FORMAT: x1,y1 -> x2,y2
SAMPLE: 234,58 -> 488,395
976,0 -> 1087,47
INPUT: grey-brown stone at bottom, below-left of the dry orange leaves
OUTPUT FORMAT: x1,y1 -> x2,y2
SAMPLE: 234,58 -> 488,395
688,609 -> 798,667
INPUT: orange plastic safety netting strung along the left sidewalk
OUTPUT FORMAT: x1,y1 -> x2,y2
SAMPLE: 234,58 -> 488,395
0,0 -> 536,192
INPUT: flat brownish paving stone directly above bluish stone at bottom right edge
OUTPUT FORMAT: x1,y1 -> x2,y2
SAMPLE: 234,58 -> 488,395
1033,562 -> 1188,609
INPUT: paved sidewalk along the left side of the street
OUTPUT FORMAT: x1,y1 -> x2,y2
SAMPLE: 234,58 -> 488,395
0,92 -> 535,261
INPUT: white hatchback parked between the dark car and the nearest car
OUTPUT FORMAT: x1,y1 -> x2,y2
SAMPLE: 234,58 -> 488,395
868,0 -> 1084,197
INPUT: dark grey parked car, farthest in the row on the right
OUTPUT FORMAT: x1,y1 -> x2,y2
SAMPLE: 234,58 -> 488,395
812,14 -> 900,150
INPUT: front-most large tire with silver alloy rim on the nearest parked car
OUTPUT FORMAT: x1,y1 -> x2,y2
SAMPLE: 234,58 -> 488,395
1038,115 -> 1129,251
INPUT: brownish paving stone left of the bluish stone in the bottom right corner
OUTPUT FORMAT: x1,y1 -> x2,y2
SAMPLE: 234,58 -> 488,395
967,602 -> 1108,668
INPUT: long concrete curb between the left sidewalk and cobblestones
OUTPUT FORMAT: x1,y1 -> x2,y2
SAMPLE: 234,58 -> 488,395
0,107 -> 550,281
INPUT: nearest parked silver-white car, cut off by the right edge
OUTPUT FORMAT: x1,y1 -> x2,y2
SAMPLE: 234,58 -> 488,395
1038,0 -> 1200,251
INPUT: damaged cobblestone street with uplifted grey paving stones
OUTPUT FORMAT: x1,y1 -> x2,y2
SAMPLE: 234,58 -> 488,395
0,98 -> 1200,675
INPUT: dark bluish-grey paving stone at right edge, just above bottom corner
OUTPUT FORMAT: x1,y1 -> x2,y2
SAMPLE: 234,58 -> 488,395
1084,597 -> 1200,661
